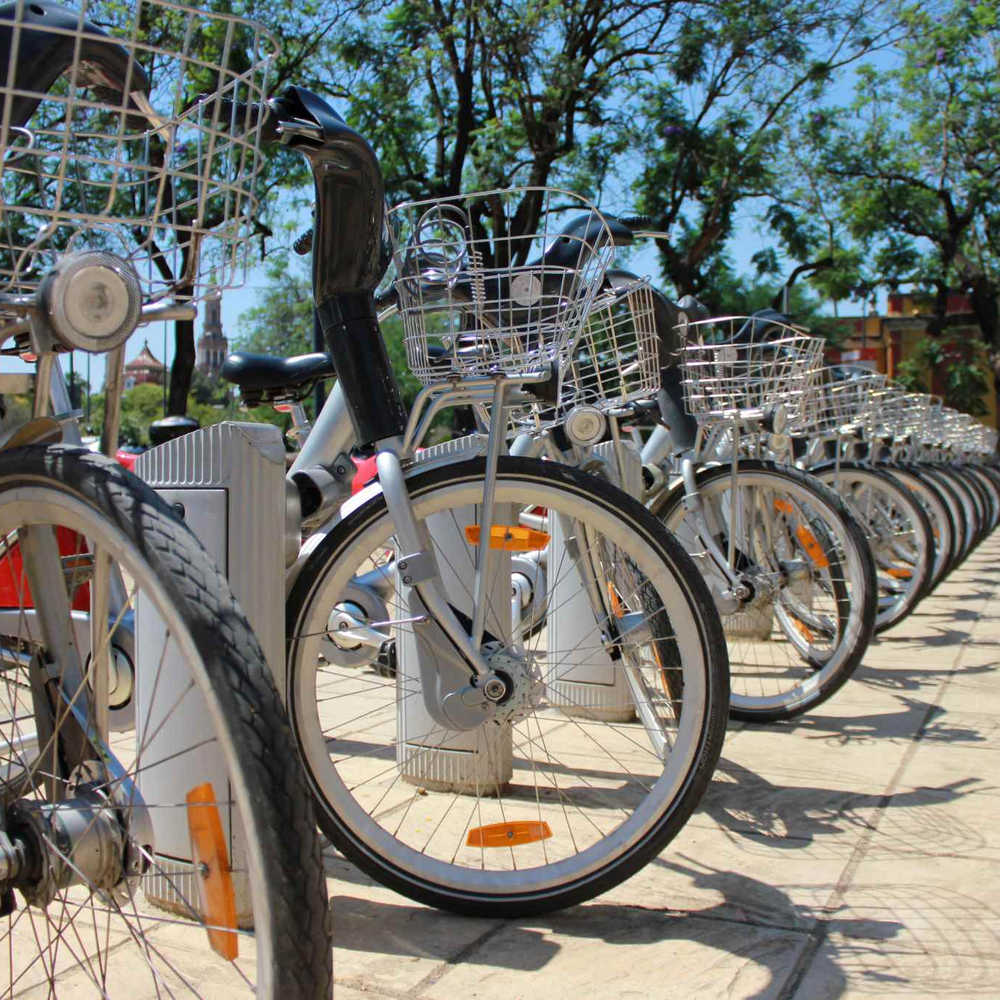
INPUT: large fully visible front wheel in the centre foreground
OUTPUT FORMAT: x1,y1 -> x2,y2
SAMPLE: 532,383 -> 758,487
288,457 -> 728,917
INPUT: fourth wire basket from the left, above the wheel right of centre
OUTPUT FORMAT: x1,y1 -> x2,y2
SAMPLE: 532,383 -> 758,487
677,316 -> 825,423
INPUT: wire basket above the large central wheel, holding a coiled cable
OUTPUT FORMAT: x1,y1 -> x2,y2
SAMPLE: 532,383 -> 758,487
389,188 -> 614,384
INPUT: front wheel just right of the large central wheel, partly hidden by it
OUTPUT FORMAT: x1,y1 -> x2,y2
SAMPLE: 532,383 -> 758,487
654,459 -> 877,722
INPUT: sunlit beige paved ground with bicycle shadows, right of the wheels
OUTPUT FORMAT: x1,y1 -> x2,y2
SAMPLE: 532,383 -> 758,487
327,533 -> 1000,1000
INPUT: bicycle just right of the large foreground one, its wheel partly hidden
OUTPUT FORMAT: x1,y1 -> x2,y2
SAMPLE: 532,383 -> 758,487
624,308 -> 876,722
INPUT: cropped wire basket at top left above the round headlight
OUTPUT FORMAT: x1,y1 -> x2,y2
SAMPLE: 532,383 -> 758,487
0,0 -> 277,300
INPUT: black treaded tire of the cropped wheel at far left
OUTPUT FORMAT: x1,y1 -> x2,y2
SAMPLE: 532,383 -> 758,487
0,445 -> 333,1000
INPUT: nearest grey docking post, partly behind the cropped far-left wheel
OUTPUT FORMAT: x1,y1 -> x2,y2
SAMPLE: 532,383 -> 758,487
135,422 -> 297,928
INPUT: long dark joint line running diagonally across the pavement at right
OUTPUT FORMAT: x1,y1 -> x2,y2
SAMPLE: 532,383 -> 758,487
777,552 -> 996,1000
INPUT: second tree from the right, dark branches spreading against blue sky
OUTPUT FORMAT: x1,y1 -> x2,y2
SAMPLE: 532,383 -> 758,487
636,0 -> 898,295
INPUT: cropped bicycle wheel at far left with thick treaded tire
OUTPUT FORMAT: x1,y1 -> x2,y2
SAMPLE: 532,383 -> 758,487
0,446 -> 332,1000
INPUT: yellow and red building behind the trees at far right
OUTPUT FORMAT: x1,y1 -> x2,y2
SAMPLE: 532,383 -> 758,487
826,293 -> 997,427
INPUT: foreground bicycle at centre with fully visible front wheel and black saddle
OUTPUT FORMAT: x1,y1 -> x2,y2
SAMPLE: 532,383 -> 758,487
223,174 -> 727,916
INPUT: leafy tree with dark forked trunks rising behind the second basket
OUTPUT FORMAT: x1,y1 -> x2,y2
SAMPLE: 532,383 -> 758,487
331,0 -> 683,206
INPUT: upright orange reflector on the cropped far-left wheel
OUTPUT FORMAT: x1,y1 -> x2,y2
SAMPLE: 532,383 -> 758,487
187,782 -> 239,962
